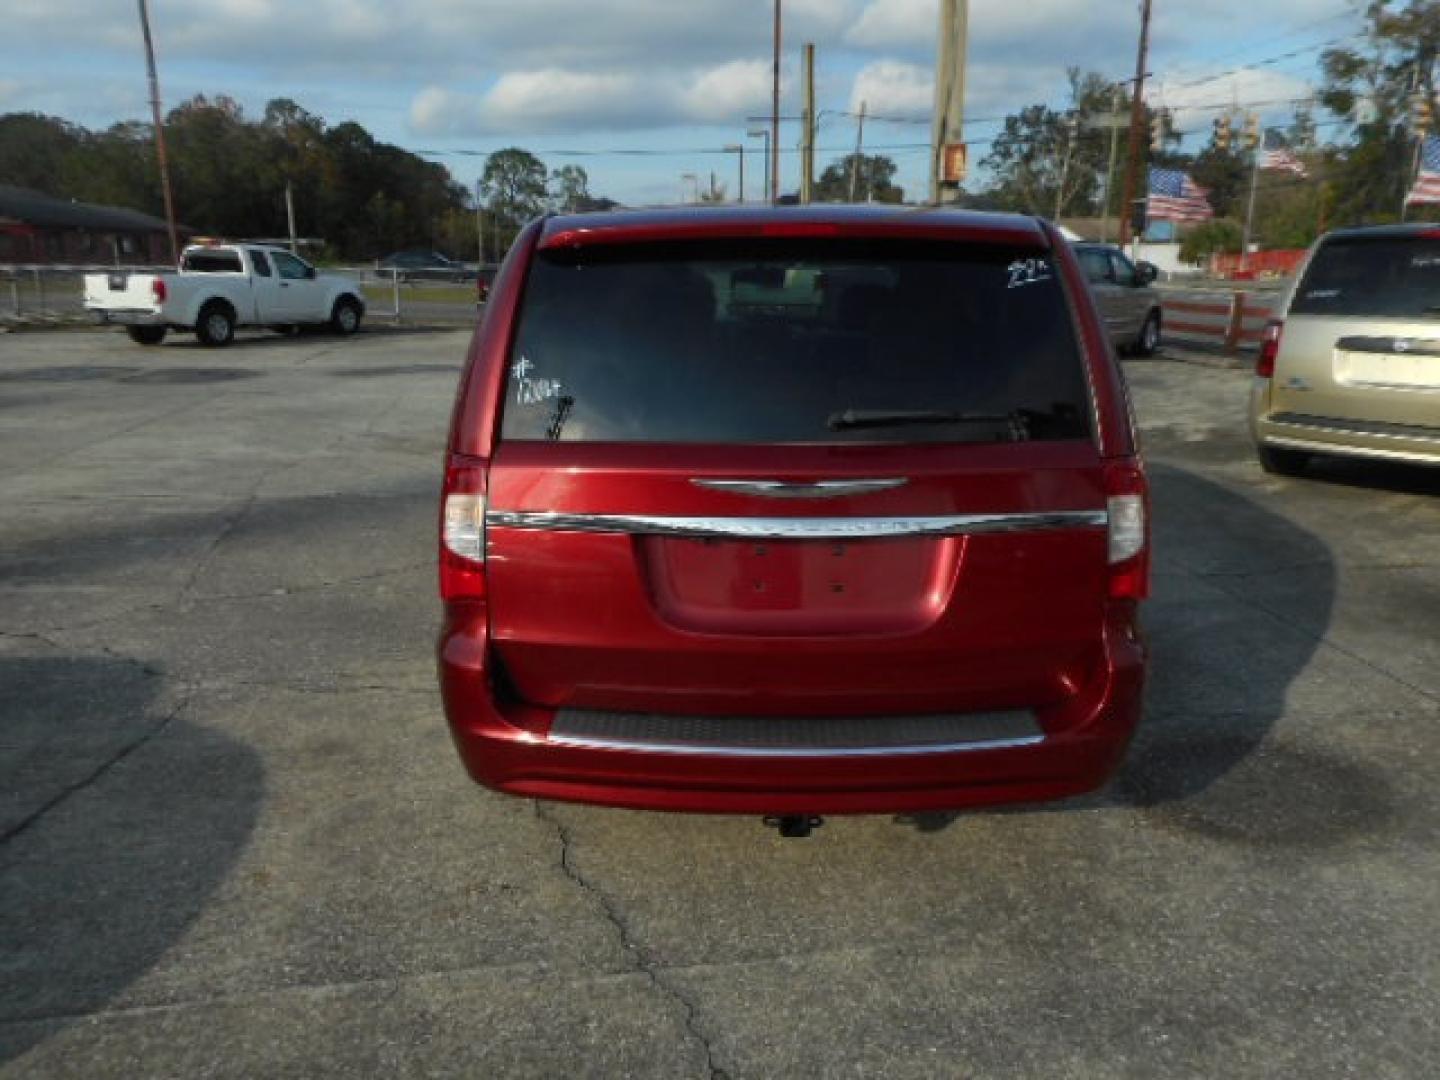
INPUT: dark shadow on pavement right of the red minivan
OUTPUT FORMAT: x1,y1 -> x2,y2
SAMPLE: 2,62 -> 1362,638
897,464 -> 1359,844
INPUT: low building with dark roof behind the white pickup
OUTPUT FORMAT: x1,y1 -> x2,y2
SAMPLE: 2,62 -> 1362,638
0,184 -> 187,266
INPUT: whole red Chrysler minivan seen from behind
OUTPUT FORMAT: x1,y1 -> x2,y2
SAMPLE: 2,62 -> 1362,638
439,206 -> 1149,815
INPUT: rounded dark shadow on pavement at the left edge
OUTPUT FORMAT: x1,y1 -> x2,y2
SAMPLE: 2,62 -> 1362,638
0,657 -> 264,1063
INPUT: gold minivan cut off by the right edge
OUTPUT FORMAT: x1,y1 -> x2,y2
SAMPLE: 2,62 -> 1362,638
1250,225 -> 1440,475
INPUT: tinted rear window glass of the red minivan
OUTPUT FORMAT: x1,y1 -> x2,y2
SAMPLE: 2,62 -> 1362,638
501,240 -> 1090,444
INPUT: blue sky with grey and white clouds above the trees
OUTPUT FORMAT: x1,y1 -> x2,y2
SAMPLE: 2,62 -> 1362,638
0,0 -> 1358,203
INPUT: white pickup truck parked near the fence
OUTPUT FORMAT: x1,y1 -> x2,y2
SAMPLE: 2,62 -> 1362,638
85,243 -> 364,346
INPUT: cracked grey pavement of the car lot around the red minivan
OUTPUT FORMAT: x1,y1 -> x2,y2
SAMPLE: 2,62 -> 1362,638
0,325 -> 1440,1079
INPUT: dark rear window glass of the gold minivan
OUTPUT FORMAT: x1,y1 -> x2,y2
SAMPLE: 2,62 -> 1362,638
1290,238 -> 1440,318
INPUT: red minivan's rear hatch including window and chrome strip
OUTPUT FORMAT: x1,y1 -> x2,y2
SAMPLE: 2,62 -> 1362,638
487,235 -> 1106,716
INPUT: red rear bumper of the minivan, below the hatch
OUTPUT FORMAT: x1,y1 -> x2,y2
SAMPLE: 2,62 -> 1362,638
439,609 -> 1145,814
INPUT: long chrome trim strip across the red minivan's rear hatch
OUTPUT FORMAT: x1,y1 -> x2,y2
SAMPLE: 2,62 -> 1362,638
485,510 -> 1109,540
